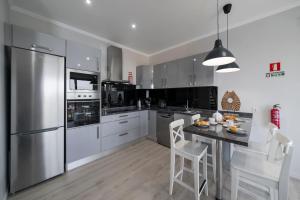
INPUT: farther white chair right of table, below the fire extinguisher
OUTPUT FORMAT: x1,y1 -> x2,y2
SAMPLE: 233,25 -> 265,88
234,123 -> 278,155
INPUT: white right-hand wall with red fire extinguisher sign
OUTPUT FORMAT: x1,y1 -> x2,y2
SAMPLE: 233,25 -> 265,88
150,7 -> 300,179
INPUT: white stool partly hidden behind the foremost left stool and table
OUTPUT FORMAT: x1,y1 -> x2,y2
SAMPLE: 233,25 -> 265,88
191,114 -> 217,181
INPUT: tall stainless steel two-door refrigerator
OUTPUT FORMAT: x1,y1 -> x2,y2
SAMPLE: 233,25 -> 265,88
9,47 -> 65,193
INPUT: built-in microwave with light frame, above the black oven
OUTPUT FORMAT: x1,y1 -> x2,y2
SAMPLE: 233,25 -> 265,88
66,69 -> 101,99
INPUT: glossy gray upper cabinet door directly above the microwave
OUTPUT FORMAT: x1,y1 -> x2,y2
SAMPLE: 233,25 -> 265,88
66,40 -> 101,72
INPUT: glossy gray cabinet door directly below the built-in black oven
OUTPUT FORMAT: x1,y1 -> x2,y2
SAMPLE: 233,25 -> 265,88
66,124 -> 101,163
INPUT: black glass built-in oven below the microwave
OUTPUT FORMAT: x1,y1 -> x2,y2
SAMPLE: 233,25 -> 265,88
67,99 -> 100,128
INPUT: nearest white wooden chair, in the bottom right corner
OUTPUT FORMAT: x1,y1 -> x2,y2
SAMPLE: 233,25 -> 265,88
231,133 -> 293,200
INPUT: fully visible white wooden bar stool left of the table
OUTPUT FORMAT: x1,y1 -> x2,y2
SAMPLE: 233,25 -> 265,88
169,119 -> 208,200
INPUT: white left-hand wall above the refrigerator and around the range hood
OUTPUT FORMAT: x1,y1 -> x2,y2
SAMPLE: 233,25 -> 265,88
10,10 -> 149,84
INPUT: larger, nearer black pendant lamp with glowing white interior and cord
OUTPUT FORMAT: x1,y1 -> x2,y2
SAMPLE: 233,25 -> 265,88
202,0 -> 236,66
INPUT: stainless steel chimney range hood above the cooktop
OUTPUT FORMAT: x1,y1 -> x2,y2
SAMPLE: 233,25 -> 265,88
103,46 -> 128,83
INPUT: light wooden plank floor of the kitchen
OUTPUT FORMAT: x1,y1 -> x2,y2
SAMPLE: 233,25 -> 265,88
9,140 -> 300,200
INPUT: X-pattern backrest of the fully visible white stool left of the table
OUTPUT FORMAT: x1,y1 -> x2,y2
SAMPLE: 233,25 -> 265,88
169,119 -> 184,149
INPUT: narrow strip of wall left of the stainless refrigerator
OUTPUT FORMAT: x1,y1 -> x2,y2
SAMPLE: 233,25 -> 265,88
0,0 -> 8,199
